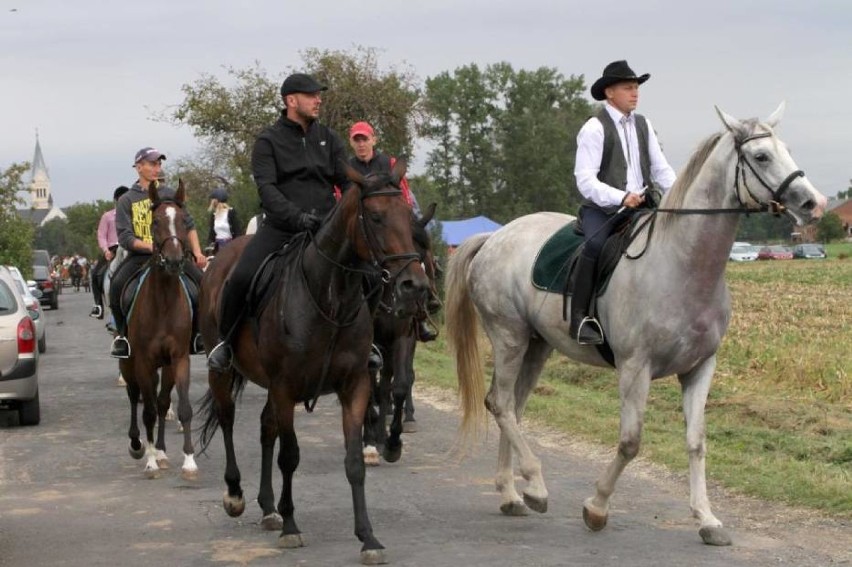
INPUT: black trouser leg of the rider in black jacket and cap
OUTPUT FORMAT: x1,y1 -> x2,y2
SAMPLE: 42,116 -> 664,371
219,223 -> 295,339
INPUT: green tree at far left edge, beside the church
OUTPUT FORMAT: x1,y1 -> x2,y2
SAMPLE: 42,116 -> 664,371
0,162 -> 33,277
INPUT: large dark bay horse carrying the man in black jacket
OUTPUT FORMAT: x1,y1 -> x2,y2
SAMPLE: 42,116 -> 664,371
199,160 -> 428,564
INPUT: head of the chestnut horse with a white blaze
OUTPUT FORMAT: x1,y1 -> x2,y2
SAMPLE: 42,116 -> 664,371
148,179 -> 190,274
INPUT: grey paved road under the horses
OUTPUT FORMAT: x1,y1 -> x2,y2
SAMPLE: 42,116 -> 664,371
0,292 -> 852,567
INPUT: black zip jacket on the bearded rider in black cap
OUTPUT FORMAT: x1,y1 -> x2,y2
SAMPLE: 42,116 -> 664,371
251,115 -> 349,233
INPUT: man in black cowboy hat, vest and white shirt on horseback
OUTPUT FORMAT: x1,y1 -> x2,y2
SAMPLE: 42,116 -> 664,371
569,61 -> 675,345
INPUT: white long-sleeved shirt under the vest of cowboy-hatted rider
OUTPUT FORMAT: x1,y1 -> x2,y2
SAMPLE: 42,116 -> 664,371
574,103 -> 676,207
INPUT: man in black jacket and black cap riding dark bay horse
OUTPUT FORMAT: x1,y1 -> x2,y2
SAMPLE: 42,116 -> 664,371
207,73 -> 381,372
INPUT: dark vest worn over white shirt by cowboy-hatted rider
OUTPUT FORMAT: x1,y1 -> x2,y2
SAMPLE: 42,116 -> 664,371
583,108 -> 651,213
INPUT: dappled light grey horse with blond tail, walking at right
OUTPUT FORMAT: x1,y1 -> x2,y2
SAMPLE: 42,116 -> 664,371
446,105 -> 826,545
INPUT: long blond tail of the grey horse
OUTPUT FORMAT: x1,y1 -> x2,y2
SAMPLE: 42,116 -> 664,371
445,234 -> 490,452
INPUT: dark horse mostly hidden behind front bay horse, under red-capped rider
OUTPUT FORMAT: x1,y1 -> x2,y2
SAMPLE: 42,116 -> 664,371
364,203 -> 437,465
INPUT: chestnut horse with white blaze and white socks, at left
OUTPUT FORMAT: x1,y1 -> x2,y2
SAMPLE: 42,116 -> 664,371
118,181 -> 198,480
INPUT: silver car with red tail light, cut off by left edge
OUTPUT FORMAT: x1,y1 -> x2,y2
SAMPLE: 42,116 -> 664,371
0,266 -> 41,425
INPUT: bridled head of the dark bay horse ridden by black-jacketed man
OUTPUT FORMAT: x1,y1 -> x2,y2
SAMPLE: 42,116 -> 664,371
347,159 -> 429,317
